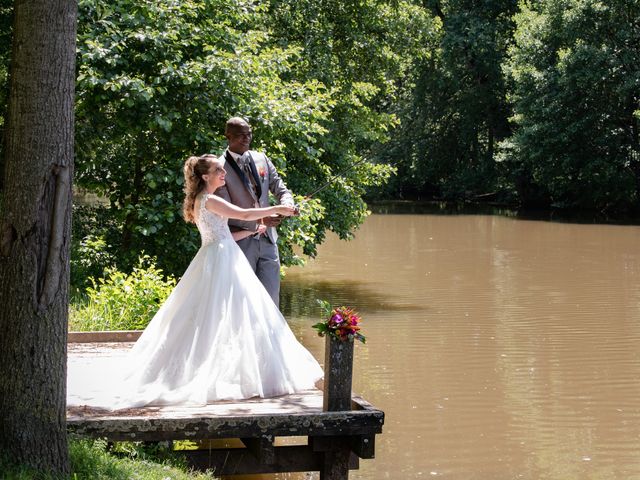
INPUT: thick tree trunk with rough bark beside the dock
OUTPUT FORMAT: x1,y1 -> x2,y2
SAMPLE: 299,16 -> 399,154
0,0 -> 77,474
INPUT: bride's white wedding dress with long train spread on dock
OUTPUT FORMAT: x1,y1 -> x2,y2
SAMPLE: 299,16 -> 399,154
67,195 -> 323,409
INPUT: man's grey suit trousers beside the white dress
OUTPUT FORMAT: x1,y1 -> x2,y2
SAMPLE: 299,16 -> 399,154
238,235 -> 280,307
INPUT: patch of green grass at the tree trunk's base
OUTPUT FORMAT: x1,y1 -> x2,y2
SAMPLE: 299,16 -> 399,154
0,438 -> 215,480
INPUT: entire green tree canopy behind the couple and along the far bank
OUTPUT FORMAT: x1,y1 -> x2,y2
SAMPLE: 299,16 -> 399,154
0,0 -> 640,282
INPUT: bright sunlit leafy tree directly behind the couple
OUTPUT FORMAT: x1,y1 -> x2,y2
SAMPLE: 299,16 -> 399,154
76,0 -> 392,274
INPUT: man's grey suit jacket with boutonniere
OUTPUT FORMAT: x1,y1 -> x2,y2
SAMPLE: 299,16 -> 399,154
215,149 -> 294,244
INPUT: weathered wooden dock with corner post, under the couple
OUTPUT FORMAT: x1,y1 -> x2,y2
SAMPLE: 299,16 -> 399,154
67,332 -> 384,480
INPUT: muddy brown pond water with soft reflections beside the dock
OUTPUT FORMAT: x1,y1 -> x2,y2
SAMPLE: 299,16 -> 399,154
280,214 -> 640,480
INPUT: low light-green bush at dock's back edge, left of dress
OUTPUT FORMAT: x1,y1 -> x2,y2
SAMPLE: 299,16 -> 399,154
69,255 -> 176,331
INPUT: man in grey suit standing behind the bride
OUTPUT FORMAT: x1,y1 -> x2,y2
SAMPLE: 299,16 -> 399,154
215,117 -> 294,306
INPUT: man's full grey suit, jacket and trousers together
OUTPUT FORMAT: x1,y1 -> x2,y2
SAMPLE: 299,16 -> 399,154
215,149 -> 294,305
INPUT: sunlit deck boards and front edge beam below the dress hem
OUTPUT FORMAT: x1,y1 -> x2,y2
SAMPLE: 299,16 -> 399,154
67,378 -> 384,441
